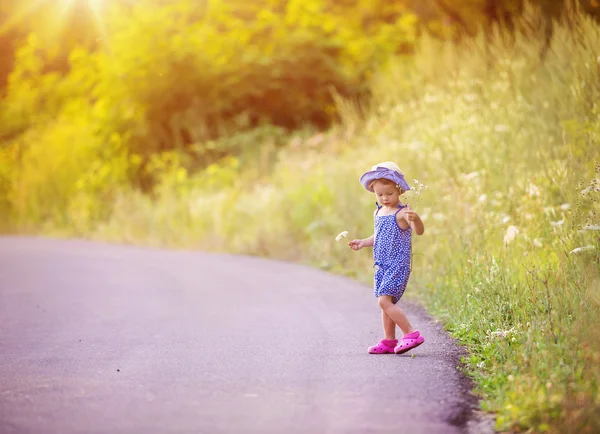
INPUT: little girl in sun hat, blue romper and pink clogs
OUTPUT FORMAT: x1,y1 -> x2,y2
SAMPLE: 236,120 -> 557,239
348,161 -> 425,354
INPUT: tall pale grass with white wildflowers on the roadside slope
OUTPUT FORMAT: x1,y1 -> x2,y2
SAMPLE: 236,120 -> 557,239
8,10 -> 600,433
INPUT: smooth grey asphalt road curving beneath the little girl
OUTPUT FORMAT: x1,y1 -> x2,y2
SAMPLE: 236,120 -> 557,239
0,237 -> 474,434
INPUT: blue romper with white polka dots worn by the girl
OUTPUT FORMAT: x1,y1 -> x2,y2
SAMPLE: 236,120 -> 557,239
373,204 -> 412,304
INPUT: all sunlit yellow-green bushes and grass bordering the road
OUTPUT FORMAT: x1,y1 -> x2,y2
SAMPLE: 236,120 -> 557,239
0,0 -> 600,433
